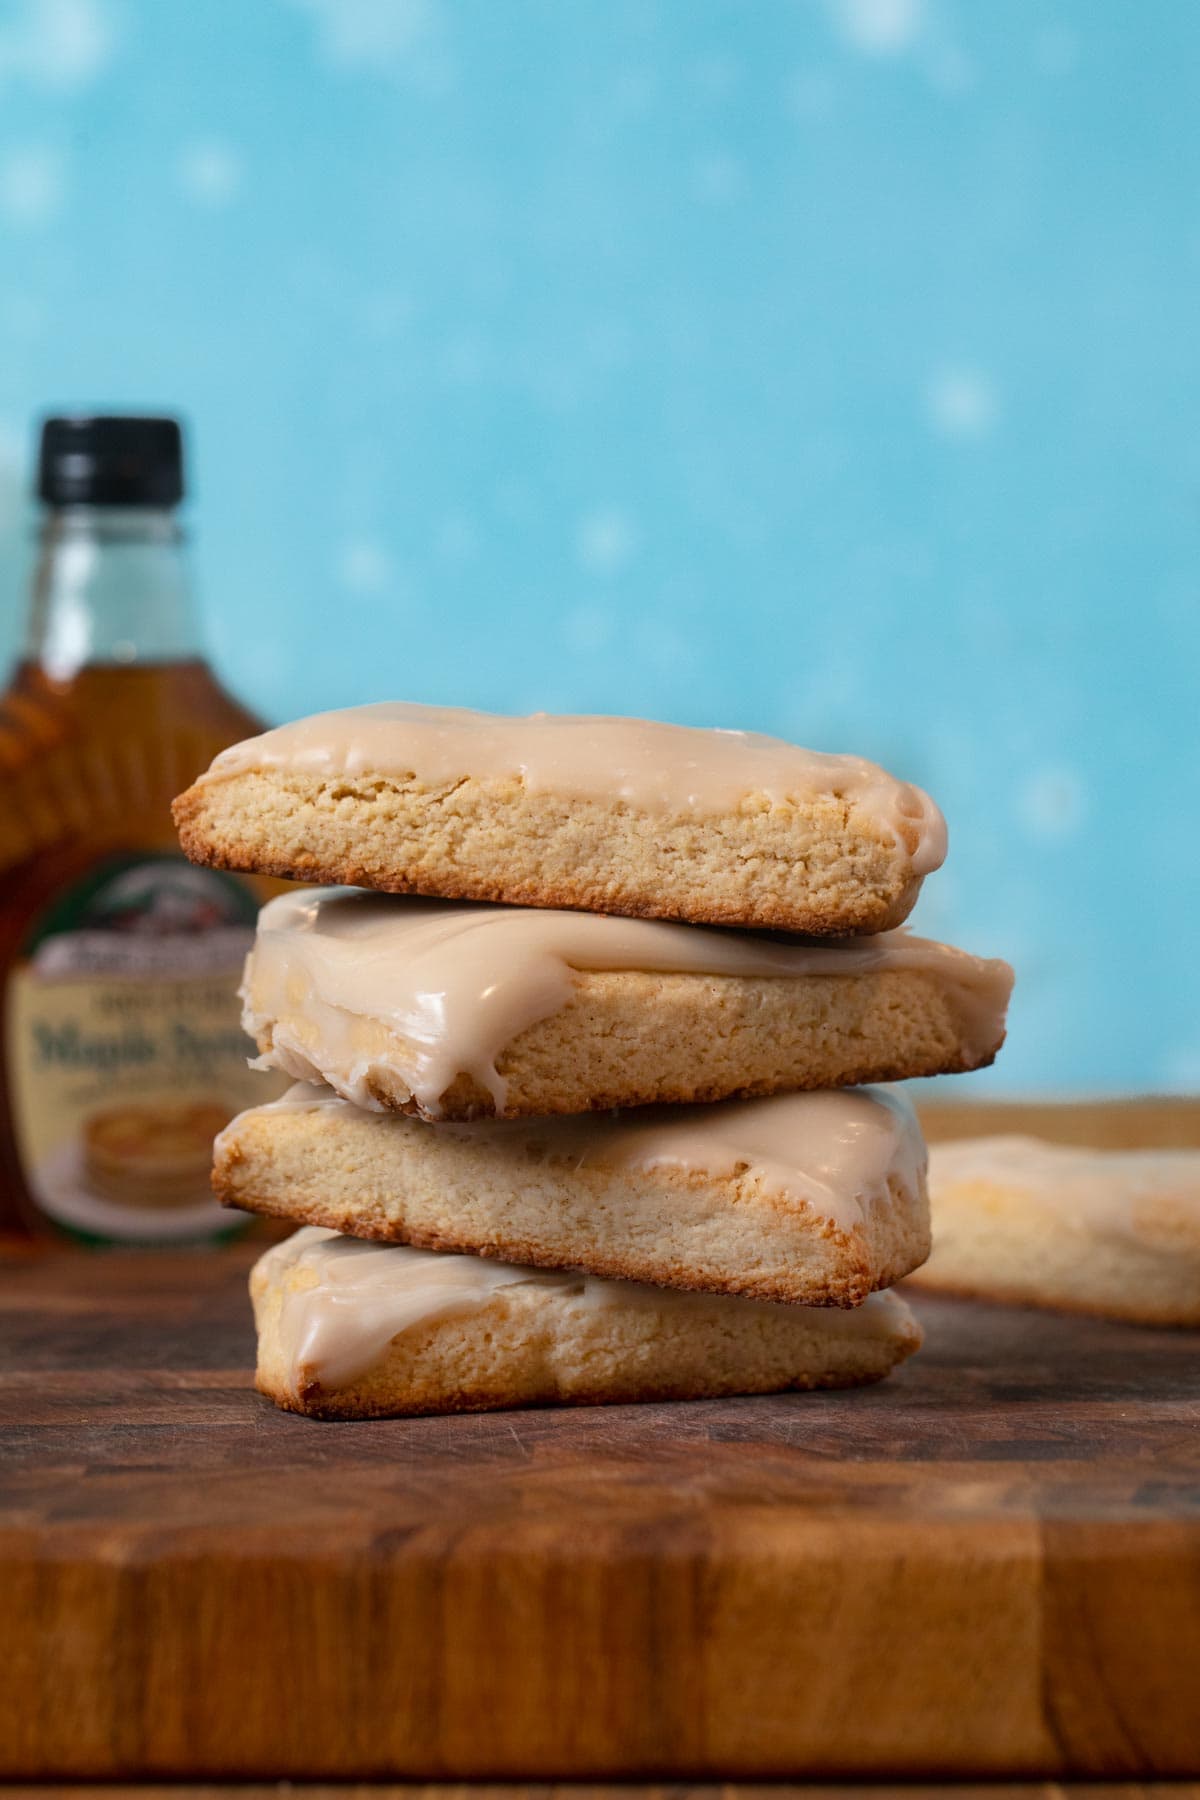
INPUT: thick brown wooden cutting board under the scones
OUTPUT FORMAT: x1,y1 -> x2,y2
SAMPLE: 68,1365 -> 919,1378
0,1109 -> 1200,1780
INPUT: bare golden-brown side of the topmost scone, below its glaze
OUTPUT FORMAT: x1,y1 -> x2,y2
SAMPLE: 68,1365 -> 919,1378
173,770 -> 921,936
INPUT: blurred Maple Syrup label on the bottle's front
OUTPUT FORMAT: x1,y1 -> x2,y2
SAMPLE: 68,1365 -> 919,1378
5,855 -> 277,1242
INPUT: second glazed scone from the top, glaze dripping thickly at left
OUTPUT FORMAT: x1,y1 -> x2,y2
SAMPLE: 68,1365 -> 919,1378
241,889 -> 1013,1120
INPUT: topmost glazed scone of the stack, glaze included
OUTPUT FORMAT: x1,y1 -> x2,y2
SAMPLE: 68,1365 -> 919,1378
175,704 -> 946,936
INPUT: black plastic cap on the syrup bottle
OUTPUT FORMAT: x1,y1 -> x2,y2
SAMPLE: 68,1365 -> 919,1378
38,414 -> 184,506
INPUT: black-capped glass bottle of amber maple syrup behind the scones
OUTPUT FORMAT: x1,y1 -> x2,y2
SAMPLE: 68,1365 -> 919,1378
0,418 -> 270,1244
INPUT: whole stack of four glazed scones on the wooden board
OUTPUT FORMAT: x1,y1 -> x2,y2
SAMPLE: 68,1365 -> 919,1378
175,704 -> 1011,1418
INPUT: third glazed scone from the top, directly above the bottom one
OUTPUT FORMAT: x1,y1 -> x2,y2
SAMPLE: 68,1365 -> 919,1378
212,1087 -> 928,1307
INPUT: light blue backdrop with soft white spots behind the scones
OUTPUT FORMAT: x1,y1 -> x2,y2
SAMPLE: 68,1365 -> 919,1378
0,0 -> 1200,1093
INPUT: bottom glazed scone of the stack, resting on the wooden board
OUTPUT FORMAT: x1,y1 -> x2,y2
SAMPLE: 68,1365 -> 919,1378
250,1228 -> 921,1418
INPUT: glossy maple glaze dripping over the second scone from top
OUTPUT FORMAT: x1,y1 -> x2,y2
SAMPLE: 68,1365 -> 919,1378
243,889 -> 1013,1116
